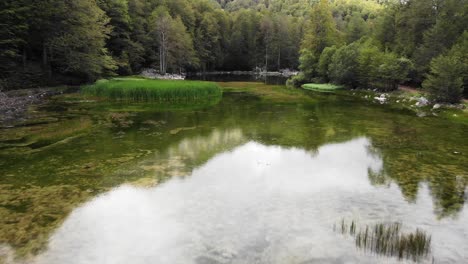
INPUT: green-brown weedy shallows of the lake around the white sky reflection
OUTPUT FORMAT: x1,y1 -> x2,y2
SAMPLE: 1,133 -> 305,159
0,82 -> 468,260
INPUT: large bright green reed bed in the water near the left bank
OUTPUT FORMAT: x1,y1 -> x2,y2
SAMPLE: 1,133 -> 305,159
81,78 -> 222,102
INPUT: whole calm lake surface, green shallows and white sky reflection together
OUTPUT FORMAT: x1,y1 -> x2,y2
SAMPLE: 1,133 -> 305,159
0,83 -> 468,263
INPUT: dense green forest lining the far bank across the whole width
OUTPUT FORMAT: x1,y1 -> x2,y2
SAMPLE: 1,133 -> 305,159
0,0 -> 468,101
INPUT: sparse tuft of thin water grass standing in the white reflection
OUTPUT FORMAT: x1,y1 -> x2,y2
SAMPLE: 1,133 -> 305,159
334,219 -> 431,261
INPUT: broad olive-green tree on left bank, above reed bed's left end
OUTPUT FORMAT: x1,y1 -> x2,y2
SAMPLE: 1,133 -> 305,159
46,0 -> 116,80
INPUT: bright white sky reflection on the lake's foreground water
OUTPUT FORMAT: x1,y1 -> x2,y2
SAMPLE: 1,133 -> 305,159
36,138 -> 468,264
